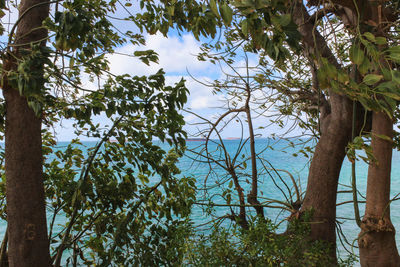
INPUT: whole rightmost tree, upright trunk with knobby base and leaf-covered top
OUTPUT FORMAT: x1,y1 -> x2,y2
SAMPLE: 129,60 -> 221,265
358,1 -> 400,266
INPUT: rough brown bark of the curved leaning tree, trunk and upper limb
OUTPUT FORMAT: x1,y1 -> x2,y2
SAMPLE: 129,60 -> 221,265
292,1 -> 352,261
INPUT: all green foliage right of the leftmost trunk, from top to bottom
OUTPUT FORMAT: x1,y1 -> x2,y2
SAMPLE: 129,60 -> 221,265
1,0 -> 195,266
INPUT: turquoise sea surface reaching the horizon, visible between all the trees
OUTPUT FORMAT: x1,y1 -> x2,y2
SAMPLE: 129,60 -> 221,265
0,138 -> 400,266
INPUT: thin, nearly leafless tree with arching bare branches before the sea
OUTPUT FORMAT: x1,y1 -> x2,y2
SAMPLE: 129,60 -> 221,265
186,54 -> 301,230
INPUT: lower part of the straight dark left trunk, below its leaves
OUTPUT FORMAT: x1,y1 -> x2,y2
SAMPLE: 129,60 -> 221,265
4,88 -> 50,266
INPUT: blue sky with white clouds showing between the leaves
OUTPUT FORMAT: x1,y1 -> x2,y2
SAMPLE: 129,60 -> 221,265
0,1 -> 297,141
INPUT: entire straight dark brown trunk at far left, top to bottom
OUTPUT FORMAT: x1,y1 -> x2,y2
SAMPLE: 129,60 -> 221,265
3,0 -> 50,267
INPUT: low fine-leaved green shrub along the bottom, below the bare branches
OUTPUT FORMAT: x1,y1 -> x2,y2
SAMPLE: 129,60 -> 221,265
186,221 -> 354,266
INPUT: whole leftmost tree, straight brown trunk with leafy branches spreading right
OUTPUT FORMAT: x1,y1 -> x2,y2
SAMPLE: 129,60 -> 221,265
1,0 -> 194,266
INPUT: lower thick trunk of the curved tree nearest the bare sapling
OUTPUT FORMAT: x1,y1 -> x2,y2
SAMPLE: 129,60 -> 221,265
302,99 -> 351,260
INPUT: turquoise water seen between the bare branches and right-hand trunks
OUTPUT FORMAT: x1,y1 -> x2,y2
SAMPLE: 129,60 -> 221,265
181,139 -> 400,262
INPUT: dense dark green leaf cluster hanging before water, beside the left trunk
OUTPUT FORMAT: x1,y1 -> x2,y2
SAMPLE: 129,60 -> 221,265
43,68 -> 194,264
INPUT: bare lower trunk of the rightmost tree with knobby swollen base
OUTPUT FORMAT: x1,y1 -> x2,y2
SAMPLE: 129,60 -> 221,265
358,112 -> 400,267
